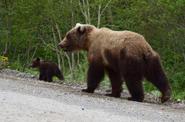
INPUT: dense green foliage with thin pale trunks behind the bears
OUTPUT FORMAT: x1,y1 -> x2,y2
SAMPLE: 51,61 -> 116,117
0,0 -> 185,99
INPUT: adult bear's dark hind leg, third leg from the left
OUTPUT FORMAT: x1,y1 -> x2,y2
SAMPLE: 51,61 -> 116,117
120,55 -> 144,102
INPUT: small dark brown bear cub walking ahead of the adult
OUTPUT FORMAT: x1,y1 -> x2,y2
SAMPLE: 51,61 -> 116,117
31,58 -> 64,82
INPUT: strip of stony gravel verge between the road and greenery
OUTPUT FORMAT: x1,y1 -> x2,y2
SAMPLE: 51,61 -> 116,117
0,69 -> 185,110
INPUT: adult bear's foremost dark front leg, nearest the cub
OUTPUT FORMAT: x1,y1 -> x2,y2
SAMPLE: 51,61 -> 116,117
82,63 -> 104,93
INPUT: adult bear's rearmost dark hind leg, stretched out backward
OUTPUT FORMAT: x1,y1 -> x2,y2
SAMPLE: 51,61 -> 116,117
145,53 -> 171,103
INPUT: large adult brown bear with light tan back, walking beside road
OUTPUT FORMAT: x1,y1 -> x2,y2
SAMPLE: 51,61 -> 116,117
59,23 -> 171,102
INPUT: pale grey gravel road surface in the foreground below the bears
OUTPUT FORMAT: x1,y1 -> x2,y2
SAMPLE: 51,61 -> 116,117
0,74 -> 185,122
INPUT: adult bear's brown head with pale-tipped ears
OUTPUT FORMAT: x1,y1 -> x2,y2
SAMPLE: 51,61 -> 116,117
59,23 -> 95,51
